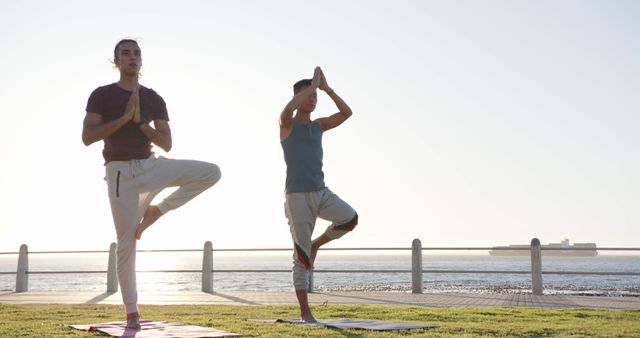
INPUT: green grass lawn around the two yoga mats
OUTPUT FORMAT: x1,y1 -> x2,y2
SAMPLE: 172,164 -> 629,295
0,304 -> 640,337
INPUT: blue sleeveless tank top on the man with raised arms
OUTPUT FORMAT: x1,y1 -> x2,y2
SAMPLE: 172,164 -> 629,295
280,118 -> 325,193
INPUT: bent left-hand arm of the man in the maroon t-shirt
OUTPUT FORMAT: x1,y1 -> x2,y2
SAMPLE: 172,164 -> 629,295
82,92 -> 139,146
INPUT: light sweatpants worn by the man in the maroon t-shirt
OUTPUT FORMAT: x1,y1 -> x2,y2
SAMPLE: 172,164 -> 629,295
106,155 -> 221,313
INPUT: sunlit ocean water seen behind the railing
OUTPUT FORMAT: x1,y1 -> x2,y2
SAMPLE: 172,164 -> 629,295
0,251 -> 640,297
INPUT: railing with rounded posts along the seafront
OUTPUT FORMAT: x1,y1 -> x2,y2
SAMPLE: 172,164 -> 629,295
0,238 -> 640,295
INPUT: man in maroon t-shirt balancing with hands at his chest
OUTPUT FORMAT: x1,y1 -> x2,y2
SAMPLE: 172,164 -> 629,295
82,39 -> 220,328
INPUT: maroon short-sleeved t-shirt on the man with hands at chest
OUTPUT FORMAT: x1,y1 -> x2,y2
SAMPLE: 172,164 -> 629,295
87,83 -> 169,163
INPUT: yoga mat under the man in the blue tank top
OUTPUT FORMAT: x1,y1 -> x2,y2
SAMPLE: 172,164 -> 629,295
250,319 -> 438,331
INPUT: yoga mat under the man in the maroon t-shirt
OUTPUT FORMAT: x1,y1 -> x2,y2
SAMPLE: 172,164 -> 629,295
68,320 -> 240,338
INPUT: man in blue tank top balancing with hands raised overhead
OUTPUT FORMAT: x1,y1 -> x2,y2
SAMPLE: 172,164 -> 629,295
280,67 -> 358,322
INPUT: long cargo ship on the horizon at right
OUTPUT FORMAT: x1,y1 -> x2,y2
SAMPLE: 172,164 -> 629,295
489,238 -> 598,257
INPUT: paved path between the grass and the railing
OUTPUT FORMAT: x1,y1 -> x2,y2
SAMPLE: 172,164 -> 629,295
0,291 -> 640,309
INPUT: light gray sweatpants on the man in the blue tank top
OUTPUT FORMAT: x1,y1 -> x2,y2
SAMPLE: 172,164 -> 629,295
284,188 -> 358,290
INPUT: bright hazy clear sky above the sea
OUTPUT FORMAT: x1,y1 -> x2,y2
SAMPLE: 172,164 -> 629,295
0,0 -> 640,252
